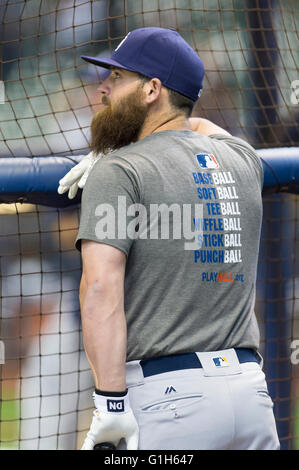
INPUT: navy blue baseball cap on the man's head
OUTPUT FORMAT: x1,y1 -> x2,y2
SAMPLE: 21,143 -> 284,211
82,27 -> 205,101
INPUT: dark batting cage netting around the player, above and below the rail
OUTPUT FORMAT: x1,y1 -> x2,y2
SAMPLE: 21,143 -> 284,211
0,0 -> 299,449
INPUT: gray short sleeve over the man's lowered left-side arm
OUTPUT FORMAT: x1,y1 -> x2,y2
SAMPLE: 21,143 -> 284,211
75,156 -> 141,255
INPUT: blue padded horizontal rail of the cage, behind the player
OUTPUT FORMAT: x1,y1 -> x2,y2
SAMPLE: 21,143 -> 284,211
0,147 -> 299,207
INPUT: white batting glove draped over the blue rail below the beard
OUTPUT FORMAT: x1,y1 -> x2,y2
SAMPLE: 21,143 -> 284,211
57,152 -> 101,199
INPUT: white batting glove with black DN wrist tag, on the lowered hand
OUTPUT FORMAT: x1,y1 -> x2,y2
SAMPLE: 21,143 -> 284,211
81,392 -> 139,450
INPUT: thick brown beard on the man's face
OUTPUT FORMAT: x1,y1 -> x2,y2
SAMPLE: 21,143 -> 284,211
91,87 -> 148,154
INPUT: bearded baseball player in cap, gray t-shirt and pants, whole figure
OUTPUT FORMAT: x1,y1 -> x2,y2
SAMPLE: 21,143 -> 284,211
59,28 -> 279,450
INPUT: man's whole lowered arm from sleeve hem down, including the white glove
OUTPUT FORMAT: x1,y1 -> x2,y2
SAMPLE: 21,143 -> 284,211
80,240 -> 138,450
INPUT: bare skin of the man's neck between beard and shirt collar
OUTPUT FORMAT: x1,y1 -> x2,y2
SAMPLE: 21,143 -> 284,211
138,114 -> 190,140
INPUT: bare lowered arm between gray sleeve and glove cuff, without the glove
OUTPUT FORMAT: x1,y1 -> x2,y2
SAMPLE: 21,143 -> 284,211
80,240 -> 127,392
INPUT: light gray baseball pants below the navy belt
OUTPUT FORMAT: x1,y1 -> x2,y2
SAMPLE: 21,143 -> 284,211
123,349 -> 279,450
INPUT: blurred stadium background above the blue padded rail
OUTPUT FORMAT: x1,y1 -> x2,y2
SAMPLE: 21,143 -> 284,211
0,0 -> 299,157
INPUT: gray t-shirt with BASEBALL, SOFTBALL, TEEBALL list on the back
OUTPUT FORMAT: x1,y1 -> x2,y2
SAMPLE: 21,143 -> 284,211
76,130 -> 263,361
